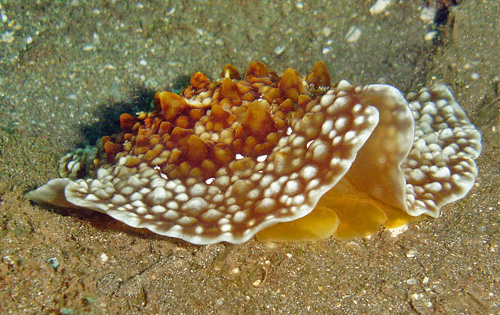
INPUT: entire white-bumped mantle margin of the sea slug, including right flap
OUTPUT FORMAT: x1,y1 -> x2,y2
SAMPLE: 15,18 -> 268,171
29,81 -> 481,244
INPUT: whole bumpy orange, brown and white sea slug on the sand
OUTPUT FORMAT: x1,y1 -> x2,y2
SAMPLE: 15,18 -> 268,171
27,62 -> 481,244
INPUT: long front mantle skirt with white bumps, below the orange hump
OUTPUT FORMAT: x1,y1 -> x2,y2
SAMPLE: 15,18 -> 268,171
27,81 -> 378,244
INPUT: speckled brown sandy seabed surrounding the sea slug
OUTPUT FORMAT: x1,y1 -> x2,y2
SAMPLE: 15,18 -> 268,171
0,0 -> 500,314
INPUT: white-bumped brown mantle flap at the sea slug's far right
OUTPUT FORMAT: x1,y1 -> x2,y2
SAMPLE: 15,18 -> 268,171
402,85 -> 481,217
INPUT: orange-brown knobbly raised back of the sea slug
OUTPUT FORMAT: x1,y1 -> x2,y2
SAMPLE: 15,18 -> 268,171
102,62 -> 330,179
